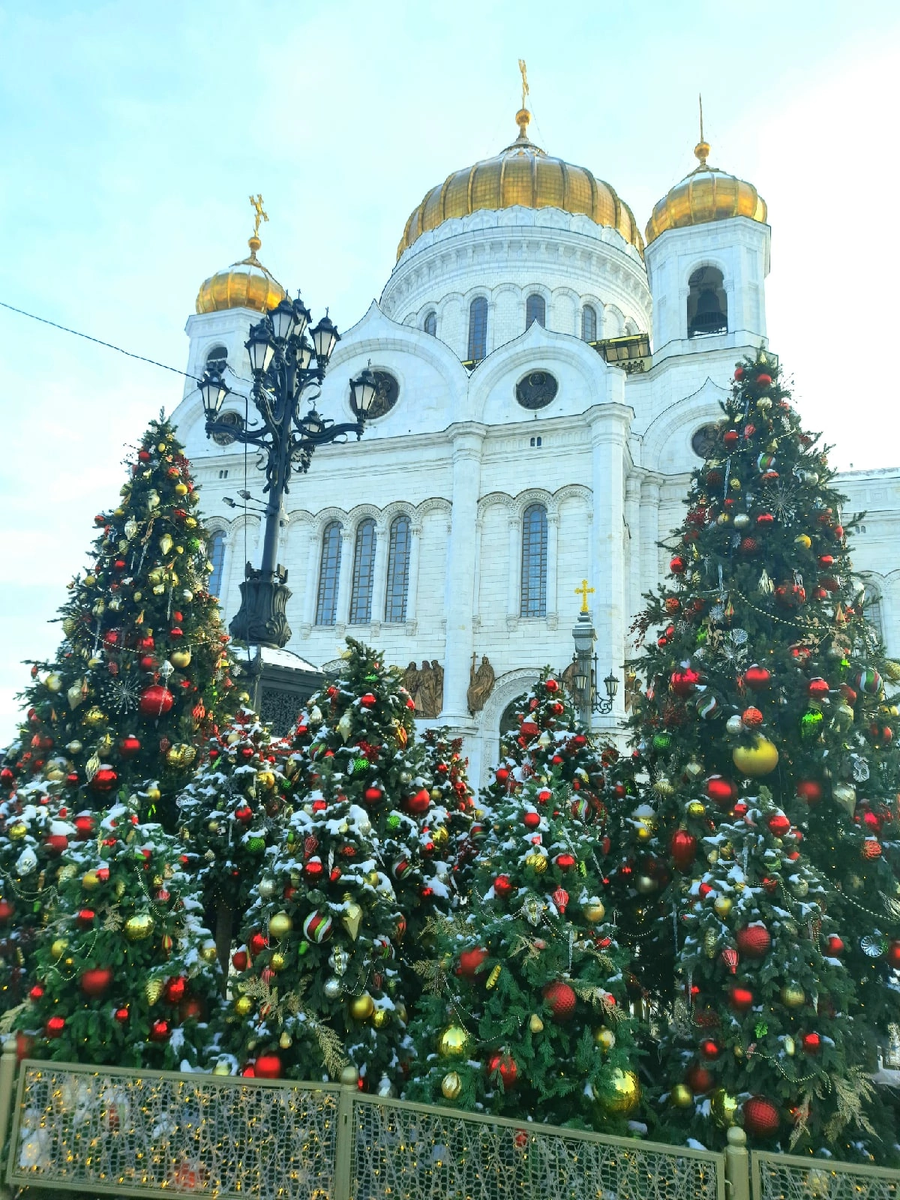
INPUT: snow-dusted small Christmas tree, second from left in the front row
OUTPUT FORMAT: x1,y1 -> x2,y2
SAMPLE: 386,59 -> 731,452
210,764 -> 409,1093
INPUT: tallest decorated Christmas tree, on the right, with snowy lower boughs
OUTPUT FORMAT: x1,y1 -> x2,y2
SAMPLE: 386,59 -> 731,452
632,352 -> 900,1157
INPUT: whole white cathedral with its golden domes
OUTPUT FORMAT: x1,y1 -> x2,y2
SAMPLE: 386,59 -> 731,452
174,98 -> 900,784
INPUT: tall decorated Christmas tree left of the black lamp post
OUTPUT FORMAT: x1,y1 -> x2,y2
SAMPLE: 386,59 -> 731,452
0,419 -> 236,822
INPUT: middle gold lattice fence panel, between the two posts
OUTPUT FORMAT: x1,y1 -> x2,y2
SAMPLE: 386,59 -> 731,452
350,1099 -> 725,1200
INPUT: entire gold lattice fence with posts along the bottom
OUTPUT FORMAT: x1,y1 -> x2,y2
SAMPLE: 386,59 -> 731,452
0,1039 -> 900,1200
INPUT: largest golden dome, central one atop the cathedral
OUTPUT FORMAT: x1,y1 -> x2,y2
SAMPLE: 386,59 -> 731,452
397,108 -> 643,258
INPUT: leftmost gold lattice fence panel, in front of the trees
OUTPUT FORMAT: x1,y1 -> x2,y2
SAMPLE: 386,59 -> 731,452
10,1063 -> 338,1200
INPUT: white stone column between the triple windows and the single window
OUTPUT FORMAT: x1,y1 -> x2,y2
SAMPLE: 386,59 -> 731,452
439,422 -> 485,726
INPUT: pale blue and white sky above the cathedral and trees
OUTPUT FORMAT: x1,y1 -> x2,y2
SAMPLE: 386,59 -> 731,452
0,0 -> 900,744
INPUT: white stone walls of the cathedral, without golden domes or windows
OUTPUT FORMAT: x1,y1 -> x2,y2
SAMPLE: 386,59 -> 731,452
175,174 -> 900,782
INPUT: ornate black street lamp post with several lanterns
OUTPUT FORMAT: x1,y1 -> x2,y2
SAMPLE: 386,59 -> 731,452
199,296 -> 376,649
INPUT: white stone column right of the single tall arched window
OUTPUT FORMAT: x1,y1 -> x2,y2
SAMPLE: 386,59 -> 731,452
590,402 -> 634,728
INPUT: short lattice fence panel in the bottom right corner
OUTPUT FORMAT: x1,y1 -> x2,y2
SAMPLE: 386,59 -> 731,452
752,1152 -> 900,1200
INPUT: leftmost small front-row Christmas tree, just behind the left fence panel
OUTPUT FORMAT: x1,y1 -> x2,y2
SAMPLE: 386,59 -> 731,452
16,805 -> 220,1069
